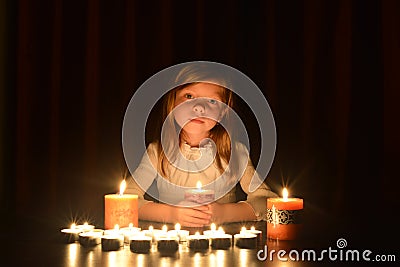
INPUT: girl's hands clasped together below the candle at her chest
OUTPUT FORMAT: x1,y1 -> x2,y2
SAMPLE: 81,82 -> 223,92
174,202 -> 211,227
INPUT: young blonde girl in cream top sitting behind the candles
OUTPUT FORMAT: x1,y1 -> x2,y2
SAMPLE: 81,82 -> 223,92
127,65 -> 276,227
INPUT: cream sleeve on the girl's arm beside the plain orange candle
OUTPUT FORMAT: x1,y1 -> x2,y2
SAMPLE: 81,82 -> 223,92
126,144 -> 158,209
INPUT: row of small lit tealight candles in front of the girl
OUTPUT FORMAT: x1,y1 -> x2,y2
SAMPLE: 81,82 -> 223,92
61,223 -> 262,253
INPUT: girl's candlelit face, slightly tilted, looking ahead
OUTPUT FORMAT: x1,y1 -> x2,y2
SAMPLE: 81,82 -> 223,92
173,83 -> 225,138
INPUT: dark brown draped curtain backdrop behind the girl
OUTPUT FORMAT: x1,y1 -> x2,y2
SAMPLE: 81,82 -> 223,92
0,0 -> 400,249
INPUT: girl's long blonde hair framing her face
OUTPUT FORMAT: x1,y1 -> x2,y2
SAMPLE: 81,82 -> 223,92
157,65 -> 233,177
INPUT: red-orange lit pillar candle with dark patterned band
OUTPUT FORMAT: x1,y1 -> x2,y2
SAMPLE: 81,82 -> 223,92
267,188 -> 303,240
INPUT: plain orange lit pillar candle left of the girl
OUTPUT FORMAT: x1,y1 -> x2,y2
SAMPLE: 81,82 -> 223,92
104,180 -> 138,229
